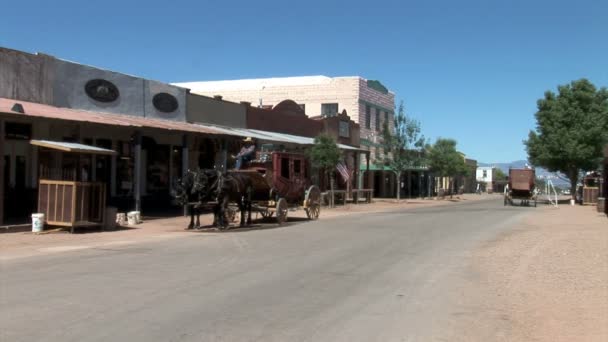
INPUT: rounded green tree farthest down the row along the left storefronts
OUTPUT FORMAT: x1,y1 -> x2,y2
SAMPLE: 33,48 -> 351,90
427,138 -> 470,194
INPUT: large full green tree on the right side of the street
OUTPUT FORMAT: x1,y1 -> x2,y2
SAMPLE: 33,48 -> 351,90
524,79 -> 608,199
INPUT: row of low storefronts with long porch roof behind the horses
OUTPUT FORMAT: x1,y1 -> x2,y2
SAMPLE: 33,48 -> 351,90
0,48 -> 366,223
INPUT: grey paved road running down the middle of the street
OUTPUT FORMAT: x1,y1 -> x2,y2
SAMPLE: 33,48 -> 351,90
0,200 -> 531,341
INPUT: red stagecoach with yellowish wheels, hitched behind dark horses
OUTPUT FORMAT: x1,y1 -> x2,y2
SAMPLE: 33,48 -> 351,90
226,151 -> 321,224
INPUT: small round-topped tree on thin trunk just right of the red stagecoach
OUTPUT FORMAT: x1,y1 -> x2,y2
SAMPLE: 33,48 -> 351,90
309,134 -> 342,207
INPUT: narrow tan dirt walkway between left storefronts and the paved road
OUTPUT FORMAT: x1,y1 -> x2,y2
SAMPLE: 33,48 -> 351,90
0,194 -> 497,261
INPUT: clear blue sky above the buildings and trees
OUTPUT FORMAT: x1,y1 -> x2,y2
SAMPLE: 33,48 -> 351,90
0,0 -> 608,162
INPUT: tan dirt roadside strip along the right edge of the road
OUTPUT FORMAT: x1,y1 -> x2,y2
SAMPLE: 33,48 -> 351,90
460,205 -> 608,342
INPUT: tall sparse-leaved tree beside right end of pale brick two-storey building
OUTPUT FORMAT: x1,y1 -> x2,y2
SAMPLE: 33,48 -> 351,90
377,101 -> 424,201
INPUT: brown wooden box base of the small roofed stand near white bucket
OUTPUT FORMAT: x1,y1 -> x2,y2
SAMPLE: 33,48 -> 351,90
38,179 -> 106,228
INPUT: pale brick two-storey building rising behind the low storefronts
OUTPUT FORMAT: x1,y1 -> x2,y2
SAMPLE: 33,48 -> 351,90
174,76 -> 396,197
